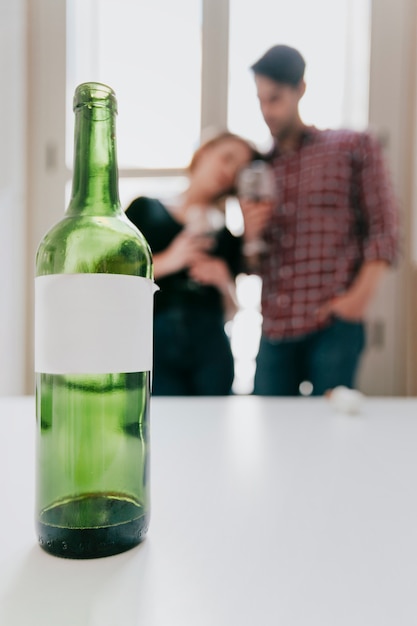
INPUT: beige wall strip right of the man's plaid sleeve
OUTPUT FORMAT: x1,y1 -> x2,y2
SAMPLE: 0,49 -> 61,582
354,0 -> 417,395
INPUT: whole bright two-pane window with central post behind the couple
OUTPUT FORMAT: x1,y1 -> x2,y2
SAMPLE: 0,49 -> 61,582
67,0 -> 371,393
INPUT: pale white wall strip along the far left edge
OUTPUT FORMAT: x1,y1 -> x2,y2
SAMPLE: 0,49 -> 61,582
0,0 -> 26,395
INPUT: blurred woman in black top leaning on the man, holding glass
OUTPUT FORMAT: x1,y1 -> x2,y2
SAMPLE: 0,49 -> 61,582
126,132 -> 255,396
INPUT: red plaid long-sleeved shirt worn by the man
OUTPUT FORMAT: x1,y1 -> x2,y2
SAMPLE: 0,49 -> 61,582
260,127 -> 398,339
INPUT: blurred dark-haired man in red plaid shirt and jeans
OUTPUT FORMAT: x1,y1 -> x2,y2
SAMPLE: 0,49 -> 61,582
241,45 -> 398,395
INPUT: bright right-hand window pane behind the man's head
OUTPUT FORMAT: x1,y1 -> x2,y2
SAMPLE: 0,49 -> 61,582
229,0 -> 371,147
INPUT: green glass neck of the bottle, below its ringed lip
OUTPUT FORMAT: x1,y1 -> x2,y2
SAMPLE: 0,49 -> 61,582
66,101 -> 122,216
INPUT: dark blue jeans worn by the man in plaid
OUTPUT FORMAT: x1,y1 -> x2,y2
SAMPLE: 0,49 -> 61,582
254,318 -> 365,396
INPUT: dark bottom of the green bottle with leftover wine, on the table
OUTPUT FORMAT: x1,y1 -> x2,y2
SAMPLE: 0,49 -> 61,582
37,495 -> 149,559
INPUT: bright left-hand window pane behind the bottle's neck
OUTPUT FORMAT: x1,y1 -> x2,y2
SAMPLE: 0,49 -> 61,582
67,0 -> 201,204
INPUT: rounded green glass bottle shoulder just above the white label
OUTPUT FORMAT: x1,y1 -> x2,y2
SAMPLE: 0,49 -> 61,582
36,215 -> 153,278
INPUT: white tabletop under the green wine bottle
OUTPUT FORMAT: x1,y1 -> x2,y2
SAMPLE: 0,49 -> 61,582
0,397 -> 417,626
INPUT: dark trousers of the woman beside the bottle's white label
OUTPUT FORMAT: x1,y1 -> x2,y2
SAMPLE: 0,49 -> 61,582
152,307 -> 234,396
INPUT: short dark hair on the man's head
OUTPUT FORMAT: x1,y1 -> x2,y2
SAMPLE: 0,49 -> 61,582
251,45 -> 306,86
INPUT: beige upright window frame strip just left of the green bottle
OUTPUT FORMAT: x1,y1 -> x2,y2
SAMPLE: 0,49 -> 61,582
25,0 -> 67,392
